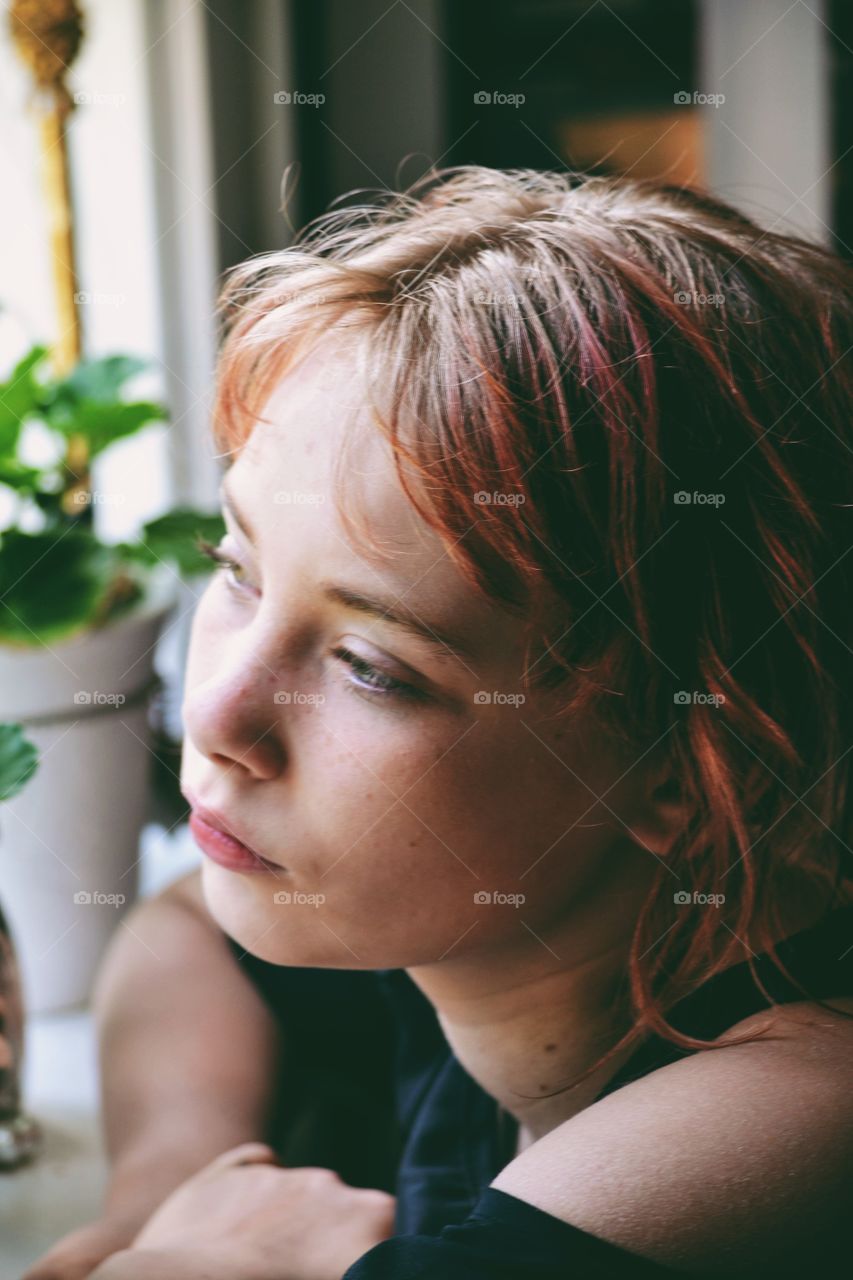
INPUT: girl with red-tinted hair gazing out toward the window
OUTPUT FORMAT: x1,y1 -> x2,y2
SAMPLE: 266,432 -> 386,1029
41,166 -> 853,1280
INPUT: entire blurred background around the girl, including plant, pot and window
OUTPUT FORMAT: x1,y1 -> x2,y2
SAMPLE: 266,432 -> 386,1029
0,0 -> 853,1280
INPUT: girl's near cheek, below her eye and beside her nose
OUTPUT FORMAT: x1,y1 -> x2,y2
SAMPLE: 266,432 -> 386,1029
302,716 -> 594,911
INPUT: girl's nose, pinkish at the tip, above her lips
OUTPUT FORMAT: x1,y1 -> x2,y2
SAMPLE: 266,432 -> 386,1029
182,650 -> 287,781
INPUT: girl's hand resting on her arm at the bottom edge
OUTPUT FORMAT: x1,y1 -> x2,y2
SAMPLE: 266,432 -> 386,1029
132,1142 -> 394,1280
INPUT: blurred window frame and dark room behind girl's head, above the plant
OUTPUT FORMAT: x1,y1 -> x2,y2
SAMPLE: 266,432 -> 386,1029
0,0 -> 853,534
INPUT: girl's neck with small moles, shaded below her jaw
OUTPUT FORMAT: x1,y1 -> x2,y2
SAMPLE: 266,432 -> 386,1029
409,851 -> 652,1138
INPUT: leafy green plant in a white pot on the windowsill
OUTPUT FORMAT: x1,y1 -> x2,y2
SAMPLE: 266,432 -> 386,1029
0,347 -> 223,1010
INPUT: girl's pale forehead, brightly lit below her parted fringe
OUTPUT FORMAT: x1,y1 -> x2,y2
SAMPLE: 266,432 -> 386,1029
228,343 -> 521,660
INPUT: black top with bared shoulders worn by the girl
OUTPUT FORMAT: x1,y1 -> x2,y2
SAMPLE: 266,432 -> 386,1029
224,906 -> 853,1280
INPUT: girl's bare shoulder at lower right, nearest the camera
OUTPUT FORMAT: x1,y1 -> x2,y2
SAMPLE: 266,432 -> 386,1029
492,998 -> 853,1277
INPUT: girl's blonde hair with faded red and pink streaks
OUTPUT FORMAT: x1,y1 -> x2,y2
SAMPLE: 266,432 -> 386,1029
208,166 -> 853,1075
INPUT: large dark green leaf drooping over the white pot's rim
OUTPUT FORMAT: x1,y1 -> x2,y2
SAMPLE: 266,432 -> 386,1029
0,527 -> 138,646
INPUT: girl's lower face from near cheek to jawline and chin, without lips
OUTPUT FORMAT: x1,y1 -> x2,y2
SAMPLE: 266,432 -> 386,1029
202,716 -> 625,968
